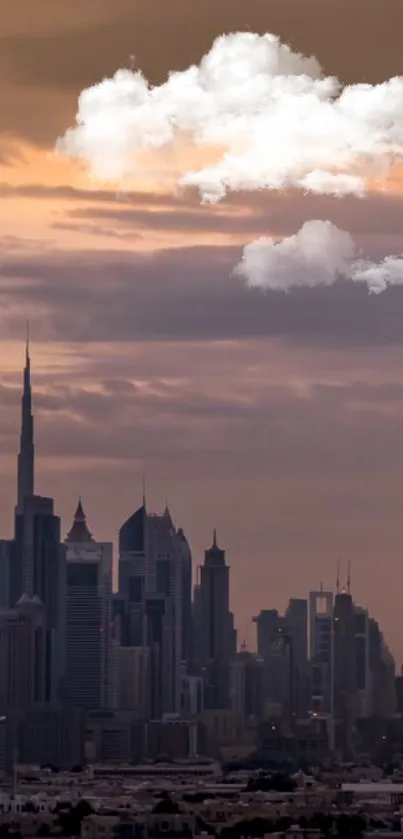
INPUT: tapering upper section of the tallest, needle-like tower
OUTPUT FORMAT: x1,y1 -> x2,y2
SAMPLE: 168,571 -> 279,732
17,321 -> 34,511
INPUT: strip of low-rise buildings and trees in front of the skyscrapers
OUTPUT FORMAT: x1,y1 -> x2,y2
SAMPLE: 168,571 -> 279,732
0,763 -> 403,839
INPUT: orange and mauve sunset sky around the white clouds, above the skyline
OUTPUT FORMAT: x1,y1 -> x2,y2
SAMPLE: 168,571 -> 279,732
0,0 -> 403,663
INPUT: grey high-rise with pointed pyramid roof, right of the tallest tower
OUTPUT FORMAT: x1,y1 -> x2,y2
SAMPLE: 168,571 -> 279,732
64,500 -> 116,710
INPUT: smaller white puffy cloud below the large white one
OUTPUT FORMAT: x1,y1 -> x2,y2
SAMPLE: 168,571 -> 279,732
233,220 -> 403,294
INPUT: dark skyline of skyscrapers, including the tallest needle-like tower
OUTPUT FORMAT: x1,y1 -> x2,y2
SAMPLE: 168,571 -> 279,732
0,344 -> 403,769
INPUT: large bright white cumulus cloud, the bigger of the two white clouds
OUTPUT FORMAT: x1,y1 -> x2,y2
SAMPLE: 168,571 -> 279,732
57,32 -> 403,202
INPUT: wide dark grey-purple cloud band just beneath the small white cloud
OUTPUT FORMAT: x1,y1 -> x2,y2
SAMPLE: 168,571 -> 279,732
0,246 -> 403,352
